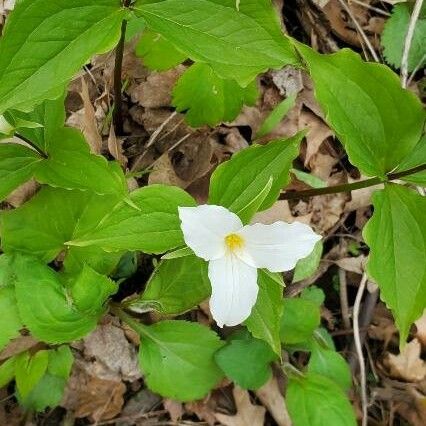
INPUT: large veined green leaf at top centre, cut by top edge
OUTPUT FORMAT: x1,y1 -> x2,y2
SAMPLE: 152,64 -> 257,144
136,0 -> 298,86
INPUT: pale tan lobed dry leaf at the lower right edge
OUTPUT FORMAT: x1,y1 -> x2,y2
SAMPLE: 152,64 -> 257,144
386,339 -> 426,382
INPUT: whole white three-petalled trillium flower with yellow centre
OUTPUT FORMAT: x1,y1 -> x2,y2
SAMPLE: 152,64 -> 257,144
179,205 -> 321,327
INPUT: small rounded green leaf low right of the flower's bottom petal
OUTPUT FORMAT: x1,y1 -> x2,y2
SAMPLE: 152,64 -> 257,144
280,298 -> 320,345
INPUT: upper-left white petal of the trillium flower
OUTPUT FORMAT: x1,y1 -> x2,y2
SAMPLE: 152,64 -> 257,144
179,205 -> 243,260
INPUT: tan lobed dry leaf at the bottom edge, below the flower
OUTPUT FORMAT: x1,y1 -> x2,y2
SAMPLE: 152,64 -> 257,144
215,386 -> 266,426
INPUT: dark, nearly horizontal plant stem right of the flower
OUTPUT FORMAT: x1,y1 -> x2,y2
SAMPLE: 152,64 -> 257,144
280,164 -> 426,200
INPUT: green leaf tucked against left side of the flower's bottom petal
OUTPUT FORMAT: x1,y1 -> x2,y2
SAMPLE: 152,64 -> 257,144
135,255 -> 211,315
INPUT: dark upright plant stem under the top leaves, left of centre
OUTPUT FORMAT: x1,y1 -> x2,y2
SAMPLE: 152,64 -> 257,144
112,0 -> 131,136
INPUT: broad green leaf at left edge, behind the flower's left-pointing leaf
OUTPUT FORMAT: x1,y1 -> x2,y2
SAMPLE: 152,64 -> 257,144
0,187 -> 119,262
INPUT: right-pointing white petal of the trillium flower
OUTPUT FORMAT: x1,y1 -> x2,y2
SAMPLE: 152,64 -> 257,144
236,222 -> 321,272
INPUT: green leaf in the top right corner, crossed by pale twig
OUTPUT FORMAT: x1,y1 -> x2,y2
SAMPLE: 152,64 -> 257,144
381,3 -> 426,71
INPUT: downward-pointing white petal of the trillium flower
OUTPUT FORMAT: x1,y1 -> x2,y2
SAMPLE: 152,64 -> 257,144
209,254 -> 259,327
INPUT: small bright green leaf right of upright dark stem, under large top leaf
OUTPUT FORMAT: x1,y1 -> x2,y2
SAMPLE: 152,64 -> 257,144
136,30 -> 187,71
